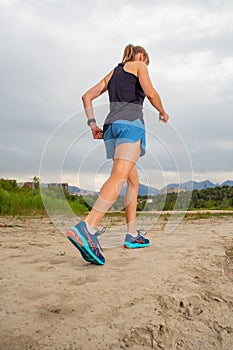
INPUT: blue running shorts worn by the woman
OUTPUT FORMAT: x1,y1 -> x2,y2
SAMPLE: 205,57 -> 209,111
103,119 -> 146,159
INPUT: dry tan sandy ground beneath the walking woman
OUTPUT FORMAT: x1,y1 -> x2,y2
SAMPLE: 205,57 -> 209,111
0,216 -> 233,350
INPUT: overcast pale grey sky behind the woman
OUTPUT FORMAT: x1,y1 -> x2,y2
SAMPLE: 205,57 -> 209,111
0,0 -> 233,189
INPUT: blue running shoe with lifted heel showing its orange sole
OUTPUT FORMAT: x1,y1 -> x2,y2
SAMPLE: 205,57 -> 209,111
66,221 -> 105,265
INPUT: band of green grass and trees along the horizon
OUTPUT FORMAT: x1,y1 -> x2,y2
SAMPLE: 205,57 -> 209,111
0,176 -> 233,218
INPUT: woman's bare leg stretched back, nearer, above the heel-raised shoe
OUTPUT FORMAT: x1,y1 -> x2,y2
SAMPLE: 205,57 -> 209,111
85,141 -> 141,227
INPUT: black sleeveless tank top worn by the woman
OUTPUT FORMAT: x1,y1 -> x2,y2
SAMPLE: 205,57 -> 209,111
104,63 -> 145,131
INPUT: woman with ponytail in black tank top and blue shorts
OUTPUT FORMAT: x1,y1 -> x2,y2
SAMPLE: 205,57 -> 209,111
67,44 -> 169,265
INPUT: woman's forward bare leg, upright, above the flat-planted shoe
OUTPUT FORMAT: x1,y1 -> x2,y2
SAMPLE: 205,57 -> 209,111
125,165 -> 139,234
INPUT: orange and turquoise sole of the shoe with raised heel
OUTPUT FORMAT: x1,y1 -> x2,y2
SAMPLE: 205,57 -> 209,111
66,227 -> 104,265
